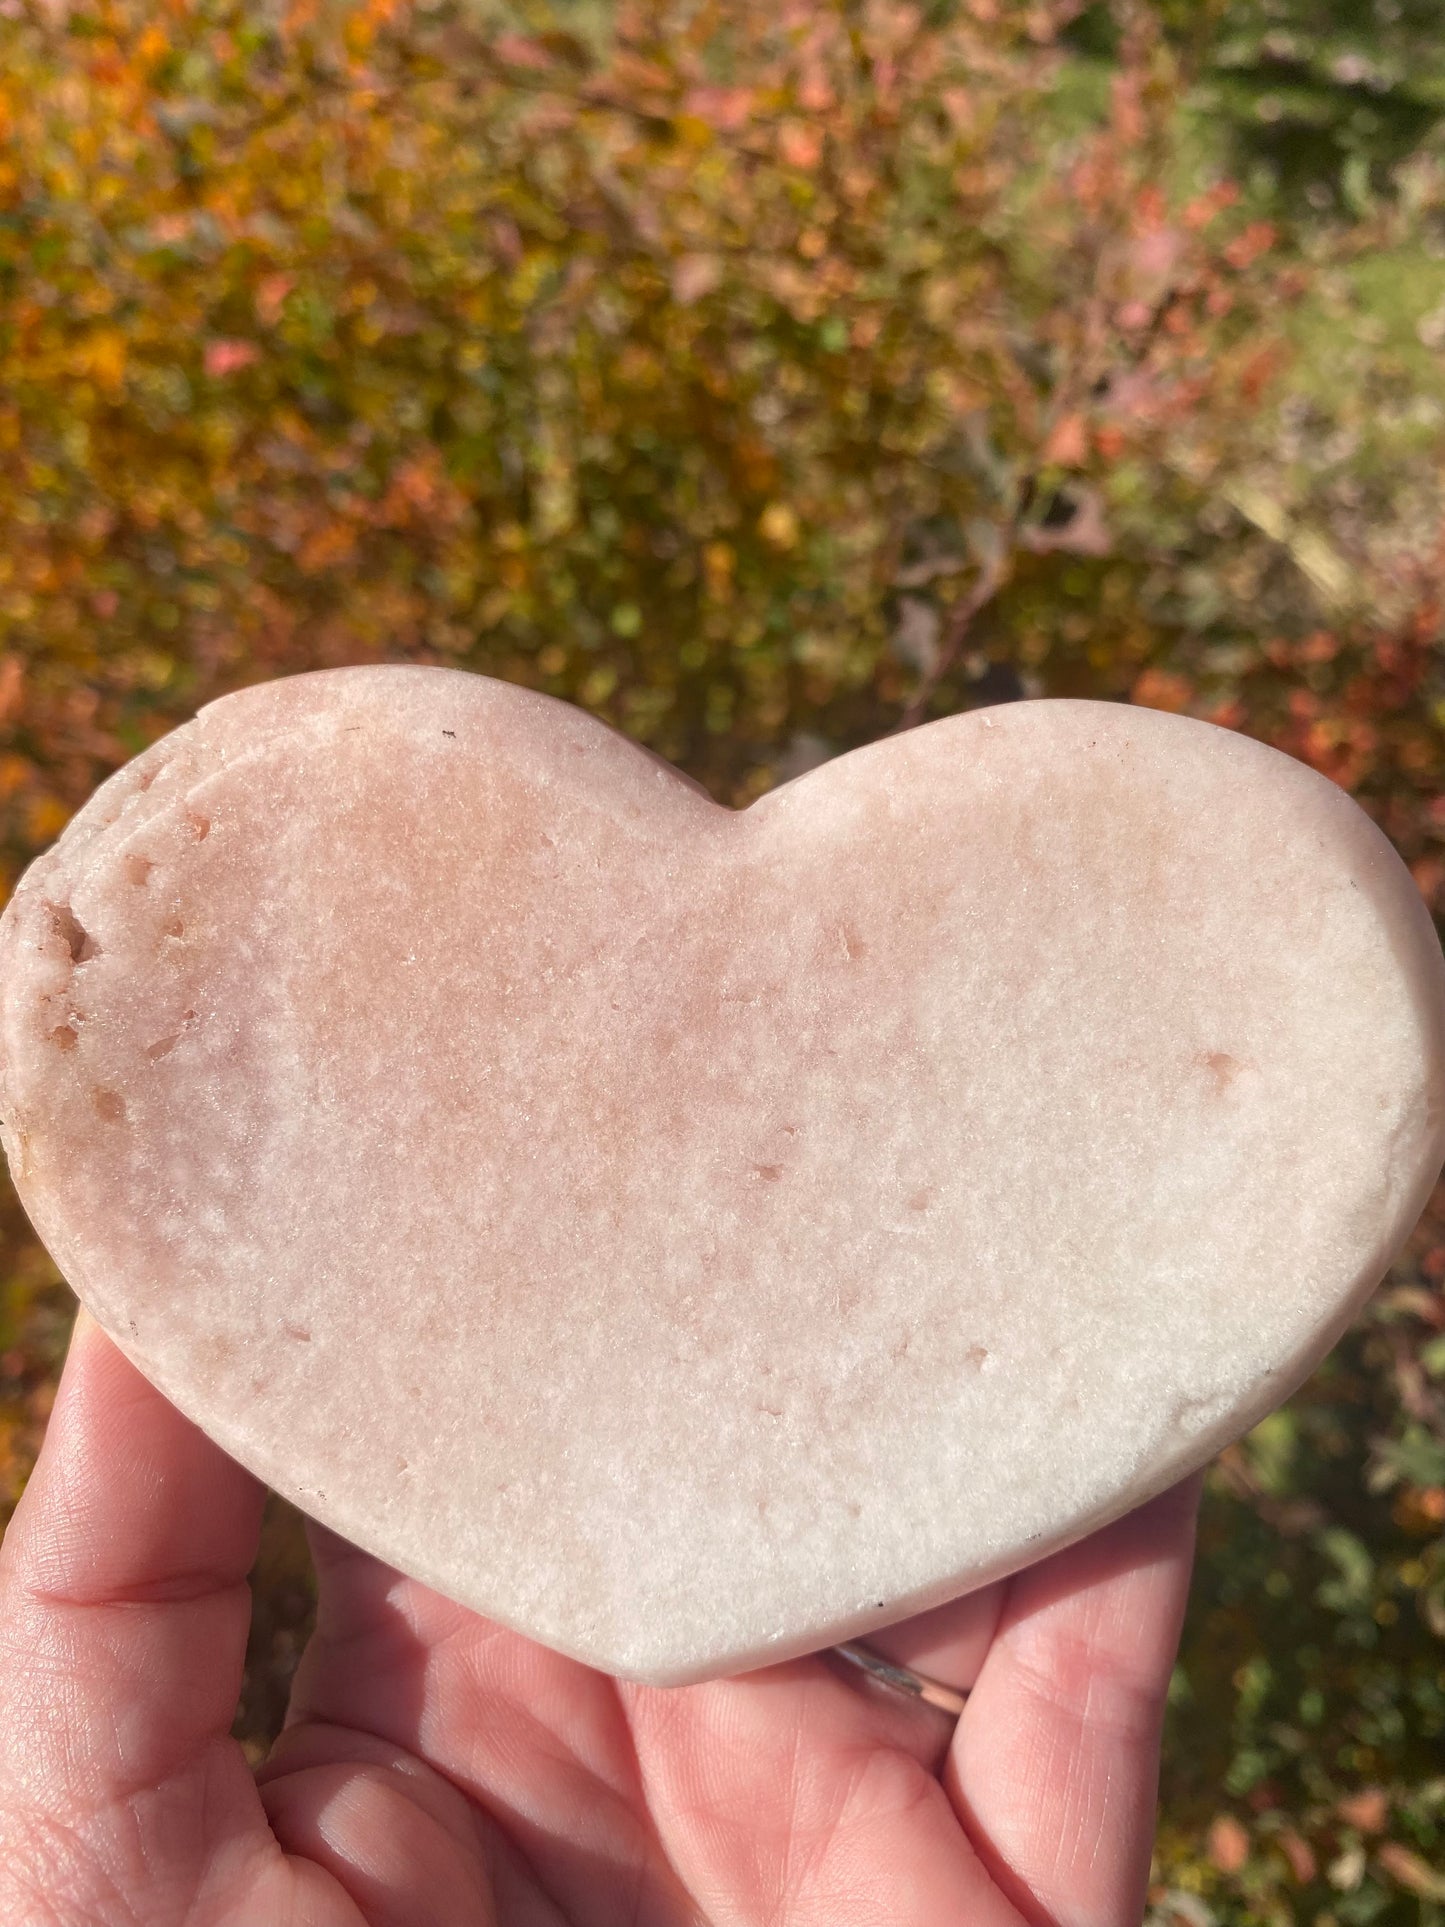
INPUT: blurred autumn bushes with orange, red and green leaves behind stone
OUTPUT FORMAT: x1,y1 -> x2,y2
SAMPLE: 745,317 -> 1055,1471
0,0 -> 1445,1927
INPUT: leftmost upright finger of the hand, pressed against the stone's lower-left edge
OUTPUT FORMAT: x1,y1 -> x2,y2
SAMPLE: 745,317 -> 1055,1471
0,1314 -> 281,1919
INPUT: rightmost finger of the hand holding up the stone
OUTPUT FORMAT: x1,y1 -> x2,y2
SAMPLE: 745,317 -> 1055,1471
944,1476 -> 1200,1927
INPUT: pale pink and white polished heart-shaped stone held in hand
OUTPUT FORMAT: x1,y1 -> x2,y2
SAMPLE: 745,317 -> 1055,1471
0,669 -> 1445,1682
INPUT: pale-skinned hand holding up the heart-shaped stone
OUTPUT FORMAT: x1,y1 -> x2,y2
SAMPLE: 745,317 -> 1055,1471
0,1314 -> 1198,1927
